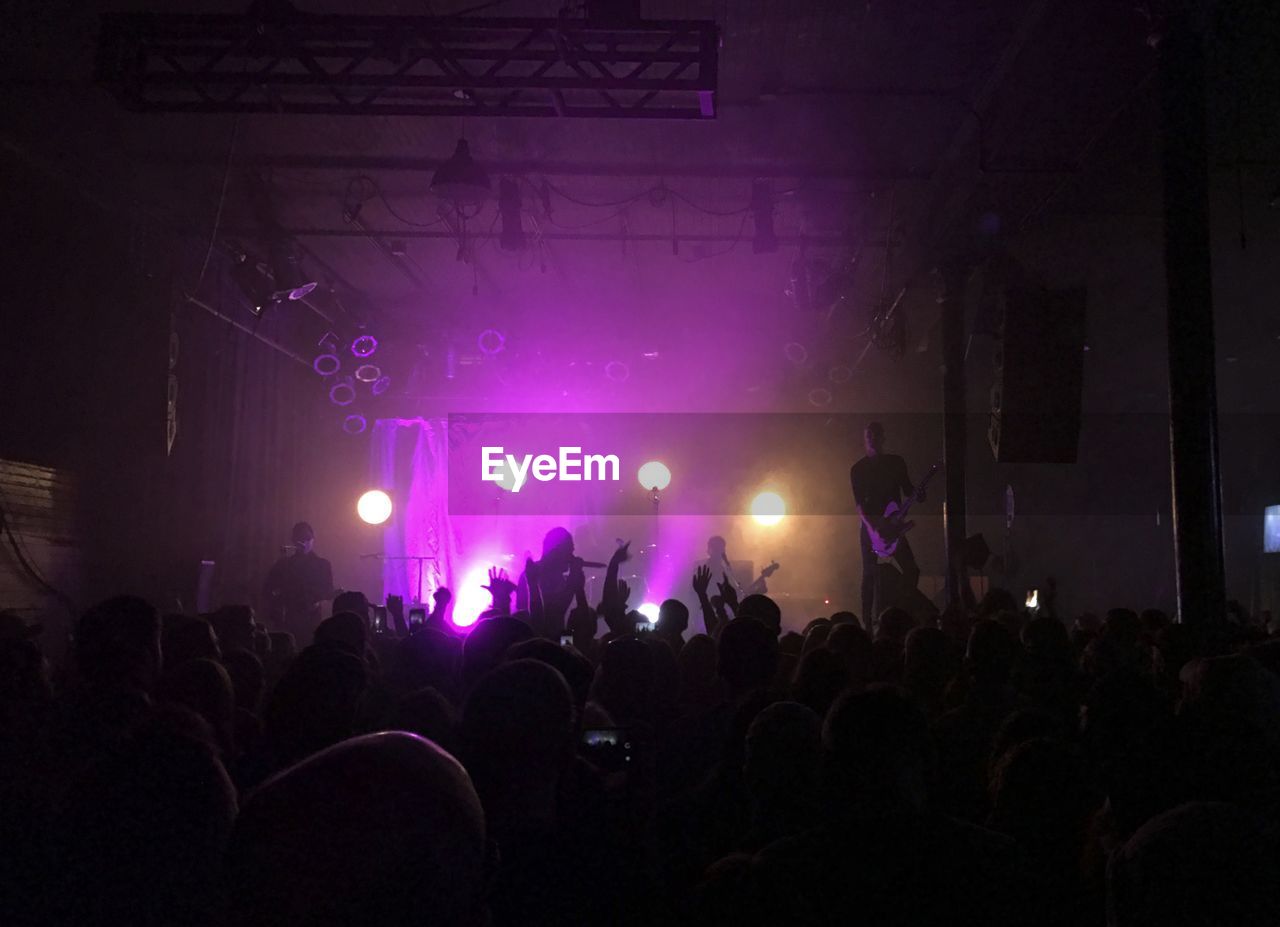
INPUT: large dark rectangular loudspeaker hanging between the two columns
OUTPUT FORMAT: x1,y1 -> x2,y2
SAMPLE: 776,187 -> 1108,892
987,288 -> 1085,464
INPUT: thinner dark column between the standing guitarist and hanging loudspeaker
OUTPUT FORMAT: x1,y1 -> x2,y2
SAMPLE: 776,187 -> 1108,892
941,265 -> 969,607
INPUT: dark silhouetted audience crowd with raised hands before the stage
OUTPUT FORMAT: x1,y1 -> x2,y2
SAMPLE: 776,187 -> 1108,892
0,535 -> 1280,927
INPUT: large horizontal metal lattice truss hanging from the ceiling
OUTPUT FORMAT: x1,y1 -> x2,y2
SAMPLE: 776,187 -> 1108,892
96,9 -> 719,119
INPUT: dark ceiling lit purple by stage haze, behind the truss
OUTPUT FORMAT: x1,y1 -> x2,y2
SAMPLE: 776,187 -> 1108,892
0,0 -> 1274,412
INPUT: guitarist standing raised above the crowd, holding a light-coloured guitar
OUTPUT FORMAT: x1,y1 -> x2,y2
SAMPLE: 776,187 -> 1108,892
849,421 -> 924,631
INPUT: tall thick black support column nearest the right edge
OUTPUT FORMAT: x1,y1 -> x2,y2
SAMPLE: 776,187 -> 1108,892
1160,14 -> 1226,629
